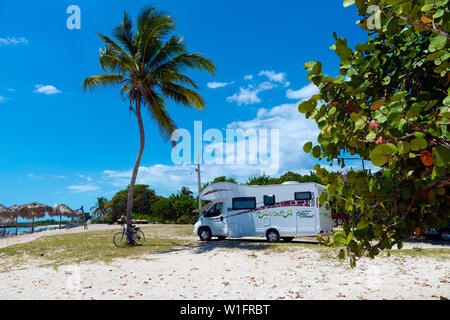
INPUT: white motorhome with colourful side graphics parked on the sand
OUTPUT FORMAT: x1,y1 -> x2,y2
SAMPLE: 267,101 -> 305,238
194,182 -> 333,242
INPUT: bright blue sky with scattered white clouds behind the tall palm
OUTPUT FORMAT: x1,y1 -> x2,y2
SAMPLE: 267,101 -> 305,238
0,0 -> 367,214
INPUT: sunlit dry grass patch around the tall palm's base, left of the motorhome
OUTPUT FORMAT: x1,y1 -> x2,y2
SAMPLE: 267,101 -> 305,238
0,226 -> 194,271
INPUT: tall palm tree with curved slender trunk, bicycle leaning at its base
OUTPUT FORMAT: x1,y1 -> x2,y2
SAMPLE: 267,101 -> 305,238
83,8 -> 216,240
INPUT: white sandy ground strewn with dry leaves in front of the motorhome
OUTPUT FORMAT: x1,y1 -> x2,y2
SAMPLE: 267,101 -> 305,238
0,226 -> 450,300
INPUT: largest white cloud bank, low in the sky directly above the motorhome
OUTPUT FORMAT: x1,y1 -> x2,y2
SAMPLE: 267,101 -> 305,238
102,103 -> 319,196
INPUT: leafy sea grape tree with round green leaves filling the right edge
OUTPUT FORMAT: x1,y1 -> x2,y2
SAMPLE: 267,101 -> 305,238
299,0 -> 450,266
